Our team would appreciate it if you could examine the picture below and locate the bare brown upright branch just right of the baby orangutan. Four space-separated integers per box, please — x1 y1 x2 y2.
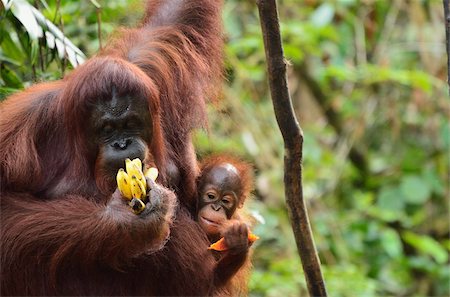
257 0 327 296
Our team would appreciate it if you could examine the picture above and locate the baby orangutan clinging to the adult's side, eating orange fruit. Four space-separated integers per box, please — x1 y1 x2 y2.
197 155 253 296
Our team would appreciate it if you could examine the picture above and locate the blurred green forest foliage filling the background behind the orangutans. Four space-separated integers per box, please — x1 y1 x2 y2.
0 0 450 296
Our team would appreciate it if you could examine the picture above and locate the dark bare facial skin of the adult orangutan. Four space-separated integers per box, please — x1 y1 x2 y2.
91 94 152 176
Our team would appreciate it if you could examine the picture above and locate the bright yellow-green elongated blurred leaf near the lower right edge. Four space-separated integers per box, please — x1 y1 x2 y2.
402 231 448 264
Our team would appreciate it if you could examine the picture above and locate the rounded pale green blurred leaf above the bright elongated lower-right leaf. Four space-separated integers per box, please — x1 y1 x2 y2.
400 175 431 204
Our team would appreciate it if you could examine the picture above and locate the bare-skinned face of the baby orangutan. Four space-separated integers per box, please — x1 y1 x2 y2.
197 163 241 237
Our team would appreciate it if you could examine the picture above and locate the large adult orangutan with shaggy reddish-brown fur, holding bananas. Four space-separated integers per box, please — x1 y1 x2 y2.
0 0 248 296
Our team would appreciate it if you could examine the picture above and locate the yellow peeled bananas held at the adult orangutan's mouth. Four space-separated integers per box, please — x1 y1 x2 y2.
116 158 158 214
